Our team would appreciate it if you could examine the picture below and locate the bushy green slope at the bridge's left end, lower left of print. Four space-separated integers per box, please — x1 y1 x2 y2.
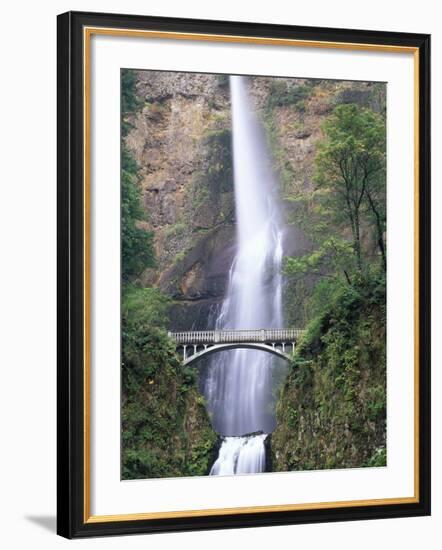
122 286 217 479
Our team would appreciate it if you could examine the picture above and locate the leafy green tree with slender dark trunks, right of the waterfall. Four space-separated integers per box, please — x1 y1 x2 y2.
314 104 386 273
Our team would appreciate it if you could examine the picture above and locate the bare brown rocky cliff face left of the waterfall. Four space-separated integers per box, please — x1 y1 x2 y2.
126 71 234 330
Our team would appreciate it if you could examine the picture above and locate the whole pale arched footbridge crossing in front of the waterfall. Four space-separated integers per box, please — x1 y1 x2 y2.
169 329 304 365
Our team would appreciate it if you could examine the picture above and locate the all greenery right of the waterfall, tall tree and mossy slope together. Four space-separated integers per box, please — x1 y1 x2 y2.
271 97 387 471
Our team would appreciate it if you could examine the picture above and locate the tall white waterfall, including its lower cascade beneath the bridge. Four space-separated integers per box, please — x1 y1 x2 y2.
205 76 283 475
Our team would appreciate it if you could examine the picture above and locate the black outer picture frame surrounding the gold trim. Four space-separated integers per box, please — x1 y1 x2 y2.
57 12 430 538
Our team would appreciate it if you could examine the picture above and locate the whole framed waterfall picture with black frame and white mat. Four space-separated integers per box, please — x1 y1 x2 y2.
58 12 430 538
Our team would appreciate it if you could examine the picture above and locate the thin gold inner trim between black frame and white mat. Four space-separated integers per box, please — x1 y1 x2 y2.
83 27 419 523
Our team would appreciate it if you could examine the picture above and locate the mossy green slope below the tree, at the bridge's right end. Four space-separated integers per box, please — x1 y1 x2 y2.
272 276 386 471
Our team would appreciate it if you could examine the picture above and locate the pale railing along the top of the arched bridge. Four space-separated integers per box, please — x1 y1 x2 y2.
169 328 304 344
